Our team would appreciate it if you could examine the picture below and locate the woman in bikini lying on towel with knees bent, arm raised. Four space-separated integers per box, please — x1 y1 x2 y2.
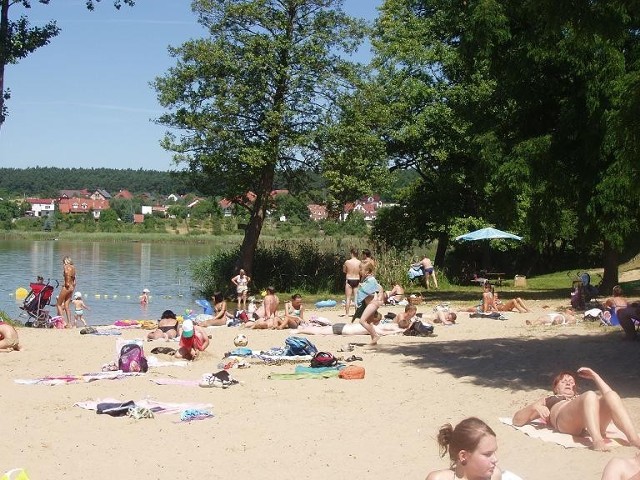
513 367 640 451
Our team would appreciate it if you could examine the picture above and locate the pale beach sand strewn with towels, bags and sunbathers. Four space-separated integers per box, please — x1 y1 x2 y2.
0 293 640 480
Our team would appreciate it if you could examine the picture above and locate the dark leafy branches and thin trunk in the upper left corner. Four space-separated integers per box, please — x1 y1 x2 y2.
0 0 135 128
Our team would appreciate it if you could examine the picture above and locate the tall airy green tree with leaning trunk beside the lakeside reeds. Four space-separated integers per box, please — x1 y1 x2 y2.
155 0 365 271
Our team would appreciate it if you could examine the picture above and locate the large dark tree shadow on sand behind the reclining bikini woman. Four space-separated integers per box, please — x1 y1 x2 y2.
377 327 640 397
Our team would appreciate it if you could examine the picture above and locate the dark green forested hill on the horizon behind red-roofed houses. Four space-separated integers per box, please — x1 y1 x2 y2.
0 167 188 197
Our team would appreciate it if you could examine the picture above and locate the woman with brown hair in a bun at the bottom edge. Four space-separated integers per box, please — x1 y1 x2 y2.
427 417 503 480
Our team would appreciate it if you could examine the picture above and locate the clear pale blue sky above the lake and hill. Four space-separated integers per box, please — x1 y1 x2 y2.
0 0 382 170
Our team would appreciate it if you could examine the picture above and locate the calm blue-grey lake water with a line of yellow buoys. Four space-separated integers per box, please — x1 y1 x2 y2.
0 240 218 325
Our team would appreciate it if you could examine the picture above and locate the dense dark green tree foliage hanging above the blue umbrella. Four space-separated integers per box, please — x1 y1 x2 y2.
370 0 640 286
